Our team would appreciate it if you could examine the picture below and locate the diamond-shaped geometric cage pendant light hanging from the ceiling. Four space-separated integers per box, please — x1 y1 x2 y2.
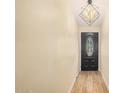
79 0 100 25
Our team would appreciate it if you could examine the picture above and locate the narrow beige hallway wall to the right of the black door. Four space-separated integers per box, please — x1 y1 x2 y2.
101 0 109 88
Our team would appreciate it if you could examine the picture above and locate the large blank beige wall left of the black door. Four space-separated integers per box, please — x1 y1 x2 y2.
16 0 78 93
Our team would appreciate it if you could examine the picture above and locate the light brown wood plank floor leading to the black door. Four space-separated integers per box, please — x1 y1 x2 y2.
71 71 108 93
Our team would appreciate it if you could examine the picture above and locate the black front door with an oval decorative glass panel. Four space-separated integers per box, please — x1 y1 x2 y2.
81 32 98 71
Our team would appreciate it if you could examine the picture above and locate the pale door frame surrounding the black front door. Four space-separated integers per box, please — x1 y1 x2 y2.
79 31 101 71
